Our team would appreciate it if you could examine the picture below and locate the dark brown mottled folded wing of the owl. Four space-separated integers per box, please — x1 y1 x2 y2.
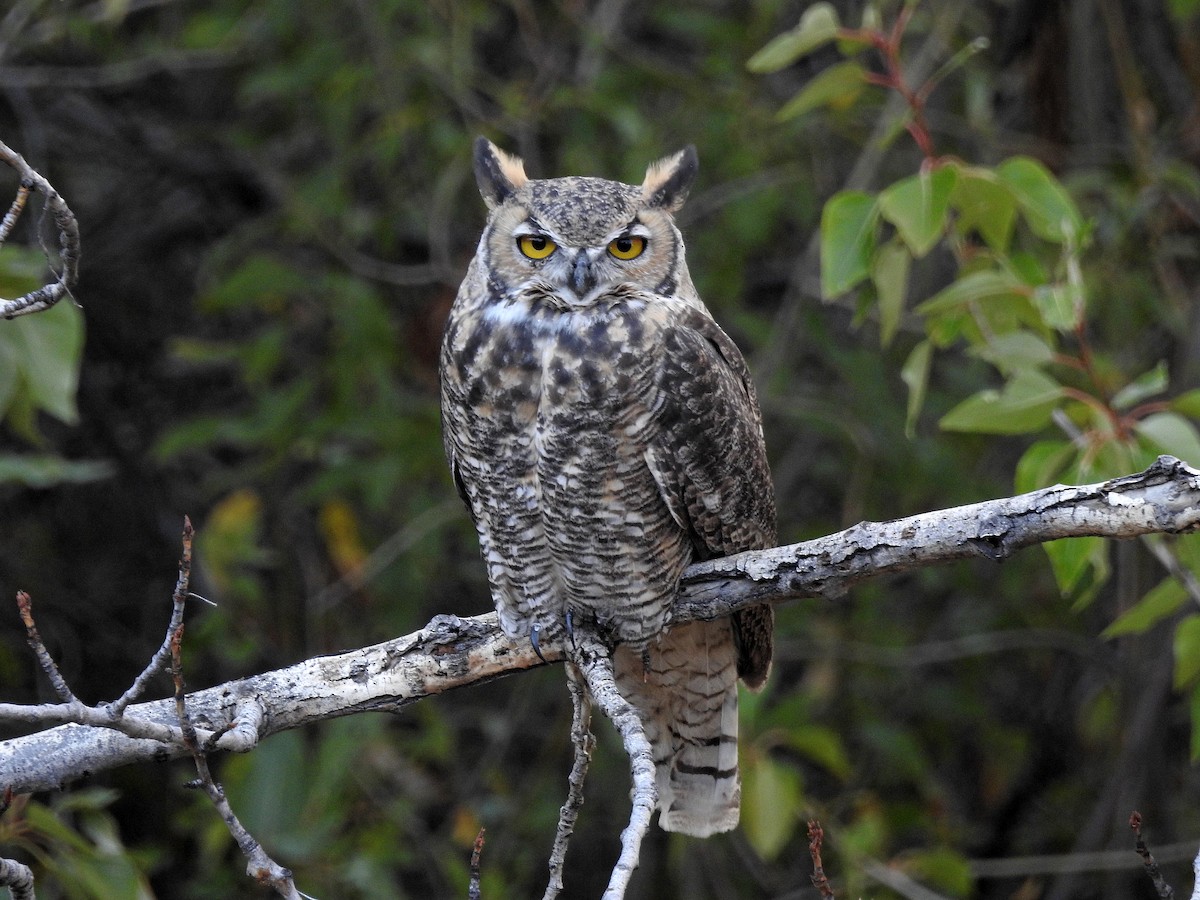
646 308 775 688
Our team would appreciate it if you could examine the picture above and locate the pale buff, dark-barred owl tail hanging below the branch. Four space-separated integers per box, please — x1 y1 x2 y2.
614 619 742 838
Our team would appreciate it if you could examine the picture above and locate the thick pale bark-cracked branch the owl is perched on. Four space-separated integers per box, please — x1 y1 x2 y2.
0 456 1200 793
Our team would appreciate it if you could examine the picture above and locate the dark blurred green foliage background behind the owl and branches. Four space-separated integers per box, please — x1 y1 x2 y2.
0 0 1200 900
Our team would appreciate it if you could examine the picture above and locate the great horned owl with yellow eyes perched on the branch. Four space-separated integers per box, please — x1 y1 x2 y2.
442 138 775 836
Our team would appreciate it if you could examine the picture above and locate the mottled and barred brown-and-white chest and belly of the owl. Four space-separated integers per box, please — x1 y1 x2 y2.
444 290 691 644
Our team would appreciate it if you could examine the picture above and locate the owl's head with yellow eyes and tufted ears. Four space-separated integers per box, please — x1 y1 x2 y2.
475 138 698 310
